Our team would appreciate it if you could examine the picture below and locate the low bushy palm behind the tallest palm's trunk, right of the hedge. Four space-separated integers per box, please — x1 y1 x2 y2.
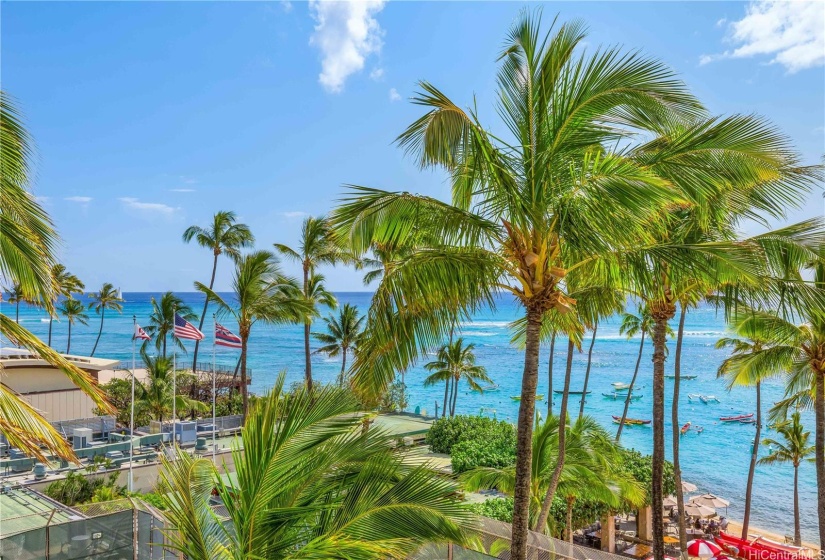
461 415 647 541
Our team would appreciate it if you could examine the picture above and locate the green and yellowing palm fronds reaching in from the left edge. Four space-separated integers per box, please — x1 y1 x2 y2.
0 90 113 462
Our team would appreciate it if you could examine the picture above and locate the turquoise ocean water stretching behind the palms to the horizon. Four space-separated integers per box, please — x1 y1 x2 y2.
1 292 817 540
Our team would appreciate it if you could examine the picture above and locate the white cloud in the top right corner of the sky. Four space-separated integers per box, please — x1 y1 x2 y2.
699 0 825 74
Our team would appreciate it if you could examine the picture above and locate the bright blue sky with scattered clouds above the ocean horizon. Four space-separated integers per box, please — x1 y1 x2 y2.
0 0 825 292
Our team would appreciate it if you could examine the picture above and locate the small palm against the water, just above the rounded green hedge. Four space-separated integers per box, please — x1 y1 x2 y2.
424 337 492 416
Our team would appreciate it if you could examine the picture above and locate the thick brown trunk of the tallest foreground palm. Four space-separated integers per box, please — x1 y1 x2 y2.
510 305 544 560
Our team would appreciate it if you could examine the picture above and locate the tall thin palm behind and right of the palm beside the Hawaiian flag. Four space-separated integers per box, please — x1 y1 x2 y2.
274 216 345 388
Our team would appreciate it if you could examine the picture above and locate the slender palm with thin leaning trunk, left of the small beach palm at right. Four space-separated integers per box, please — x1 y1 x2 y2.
716 305 777 539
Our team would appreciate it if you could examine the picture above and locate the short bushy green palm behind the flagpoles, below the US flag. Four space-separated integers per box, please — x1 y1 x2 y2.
135 348 209 422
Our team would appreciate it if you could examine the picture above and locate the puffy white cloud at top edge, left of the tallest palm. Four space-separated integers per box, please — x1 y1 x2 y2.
309 0 385 93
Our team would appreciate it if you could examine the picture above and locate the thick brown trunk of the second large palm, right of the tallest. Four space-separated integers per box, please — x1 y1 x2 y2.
651 301 676 560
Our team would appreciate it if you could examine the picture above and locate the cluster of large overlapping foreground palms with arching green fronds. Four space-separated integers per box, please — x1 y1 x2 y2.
331 12 825 560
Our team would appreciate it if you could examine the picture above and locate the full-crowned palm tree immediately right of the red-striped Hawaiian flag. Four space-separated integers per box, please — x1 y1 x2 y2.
195 251 316 419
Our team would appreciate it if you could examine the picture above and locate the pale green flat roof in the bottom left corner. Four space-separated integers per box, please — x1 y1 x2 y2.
0 487 83 538
